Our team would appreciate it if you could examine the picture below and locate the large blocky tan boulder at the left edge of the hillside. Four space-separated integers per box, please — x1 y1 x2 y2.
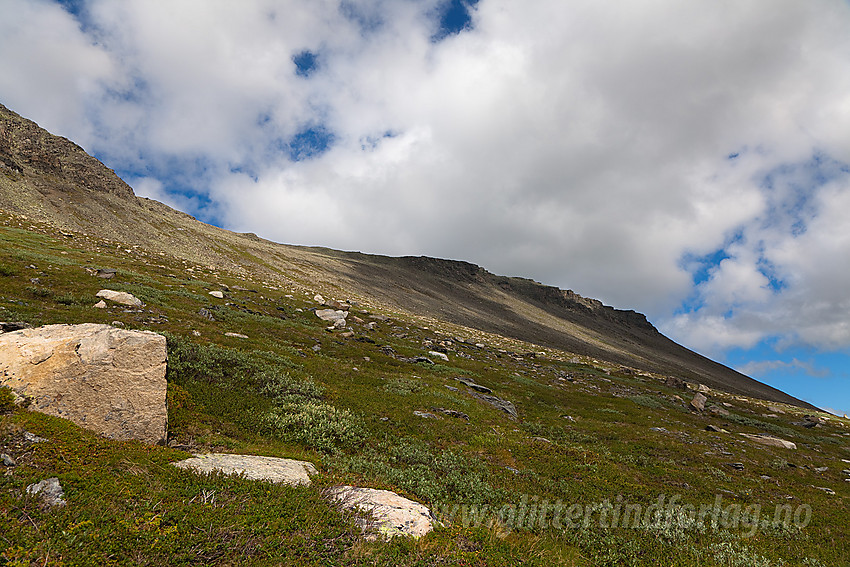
0 323 168 443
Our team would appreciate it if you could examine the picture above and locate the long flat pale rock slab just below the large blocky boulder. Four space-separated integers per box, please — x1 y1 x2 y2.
173 453 319 486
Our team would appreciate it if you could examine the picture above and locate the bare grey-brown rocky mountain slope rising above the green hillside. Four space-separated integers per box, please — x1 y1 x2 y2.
0 105 812 407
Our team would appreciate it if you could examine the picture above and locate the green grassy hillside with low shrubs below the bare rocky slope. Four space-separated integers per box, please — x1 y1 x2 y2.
0 211 850 566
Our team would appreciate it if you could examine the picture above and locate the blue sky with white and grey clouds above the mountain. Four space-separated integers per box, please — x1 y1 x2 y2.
0 0 850 413
